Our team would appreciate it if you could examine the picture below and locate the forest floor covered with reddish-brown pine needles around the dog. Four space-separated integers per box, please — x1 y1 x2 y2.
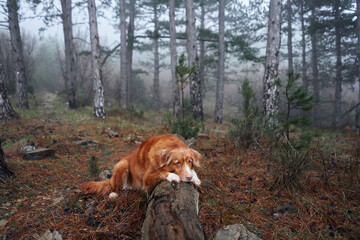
0 94 360 239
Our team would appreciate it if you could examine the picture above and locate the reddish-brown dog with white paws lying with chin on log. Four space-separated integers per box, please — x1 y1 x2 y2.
80 135 201 197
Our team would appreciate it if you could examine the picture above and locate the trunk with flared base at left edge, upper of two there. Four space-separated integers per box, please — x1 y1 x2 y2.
0 62 19 122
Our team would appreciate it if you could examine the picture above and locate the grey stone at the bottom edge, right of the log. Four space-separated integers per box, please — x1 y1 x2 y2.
215 224 261 240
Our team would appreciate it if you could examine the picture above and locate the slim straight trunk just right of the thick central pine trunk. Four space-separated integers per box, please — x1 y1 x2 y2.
215 0 225 123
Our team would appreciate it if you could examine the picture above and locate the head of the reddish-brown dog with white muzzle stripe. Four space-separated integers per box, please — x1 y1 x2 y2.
159 148 201 182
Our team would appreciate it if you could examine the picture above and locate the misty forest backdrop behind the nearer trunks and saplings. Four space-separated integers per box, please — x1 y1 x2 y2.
1 0 360 127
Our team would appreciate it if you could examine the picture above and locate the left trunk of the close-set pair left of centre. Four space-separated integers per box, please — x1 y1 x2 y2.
119 0 129 109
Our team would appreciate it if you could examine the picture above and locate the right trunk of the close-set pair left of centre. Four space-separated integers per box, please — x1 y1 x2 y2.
127 0 136 104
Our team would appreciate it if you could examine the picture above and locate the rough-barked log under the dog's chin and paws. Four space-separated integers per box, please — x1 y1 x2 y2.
141 181 205 240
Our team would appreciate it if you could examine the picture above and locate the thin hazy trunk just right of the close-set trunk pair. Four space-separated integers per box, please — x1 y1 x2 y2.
153 3 160 110
